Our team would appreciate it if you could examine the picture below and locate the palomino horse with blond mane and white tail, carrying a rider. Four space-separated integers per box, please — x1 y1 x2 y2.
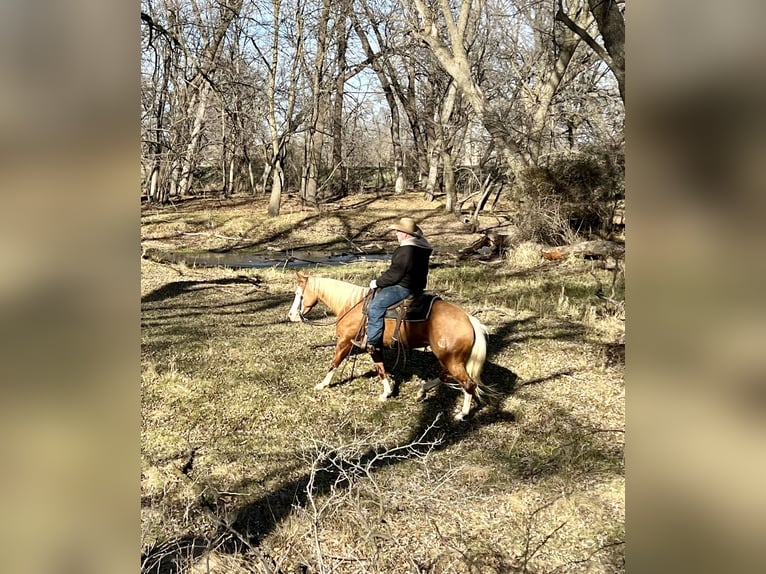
287 272 488 420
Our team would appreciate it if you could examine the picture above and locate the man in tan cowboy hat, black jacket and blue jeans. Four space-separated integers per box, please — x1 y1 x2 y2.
367 217 433 353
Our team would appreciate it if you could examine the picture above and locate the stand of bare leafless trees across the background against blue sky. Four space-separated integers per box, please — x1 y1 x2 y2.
141 0 624 215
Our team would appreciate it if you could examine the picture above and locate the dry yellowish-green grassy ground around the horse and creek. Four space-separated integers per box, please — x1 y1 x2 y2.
141 195 625 573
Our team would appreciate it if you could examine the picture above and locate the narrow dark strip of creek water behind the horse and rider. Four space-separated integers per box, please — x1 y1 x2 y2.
143 249 391 269
